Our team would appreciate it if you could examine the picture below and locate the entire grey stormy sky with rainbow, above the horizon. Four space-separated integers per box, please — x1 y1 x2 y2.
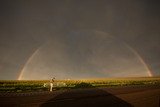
0 0 160 79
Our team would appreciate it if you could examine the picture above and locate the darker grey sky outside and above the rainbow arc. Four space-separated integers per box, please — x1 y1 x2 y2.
0 0 160 79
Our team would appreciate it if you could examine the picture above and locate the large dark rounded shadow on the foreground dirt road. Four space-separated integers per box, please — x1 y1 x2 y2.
40 88 133 107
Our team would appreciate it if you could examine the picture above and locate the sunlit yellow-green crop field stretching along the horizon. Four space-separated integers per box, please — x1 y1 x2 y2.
0 77 160 93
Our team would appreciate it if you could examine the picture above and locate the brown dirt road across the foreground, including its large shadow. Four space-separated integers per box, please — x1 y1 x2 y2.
0 87 160 107
